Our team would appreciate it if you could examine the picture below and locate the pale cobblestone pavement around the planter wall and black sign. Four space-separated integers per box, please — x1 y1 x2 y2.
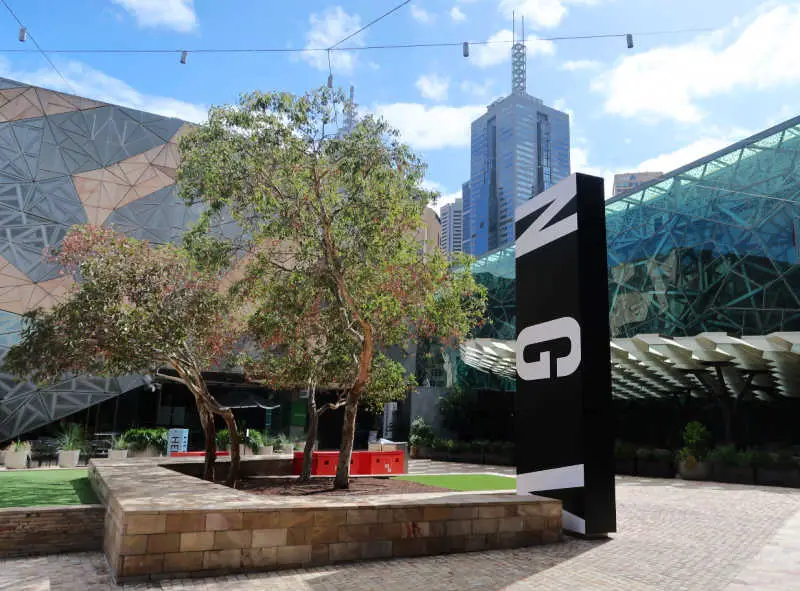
0 474 800 591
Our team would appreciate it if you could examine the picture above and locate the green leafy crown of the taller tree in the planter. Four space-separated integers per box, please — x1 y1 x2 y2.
178 88 486 476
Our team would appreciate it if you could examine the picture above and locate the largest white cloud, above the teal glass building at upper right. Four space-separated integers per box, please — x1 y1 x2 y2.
592 3 800 123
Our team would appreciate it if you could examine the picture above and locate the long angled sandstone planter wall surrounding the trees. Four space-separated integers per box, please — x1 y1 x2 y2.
89 458 562 581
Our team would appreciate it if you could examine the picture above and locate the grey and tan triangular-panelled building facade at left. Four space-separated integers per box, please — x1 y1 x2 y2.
0 78 200 441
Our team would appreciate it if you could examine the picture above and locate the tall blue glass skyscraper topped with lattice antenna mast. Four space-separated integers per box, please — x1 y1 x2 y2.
463 31 570 256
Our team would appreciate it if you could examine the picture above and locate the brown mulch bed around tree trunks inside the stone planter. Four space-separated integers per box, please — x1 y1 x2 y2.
237 477 447 497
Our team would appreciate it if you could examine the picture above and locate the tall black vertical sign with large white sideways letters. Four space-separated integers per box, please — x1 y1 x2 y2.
515 174 616 536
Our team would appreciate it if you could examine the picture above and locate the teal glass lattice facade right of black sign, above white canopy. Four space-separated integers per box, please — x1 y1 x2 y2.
606 118 800 337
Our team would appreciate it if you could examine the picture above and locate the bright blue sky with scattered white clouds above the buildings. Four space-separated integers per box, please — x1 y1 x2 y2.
0 0 800 210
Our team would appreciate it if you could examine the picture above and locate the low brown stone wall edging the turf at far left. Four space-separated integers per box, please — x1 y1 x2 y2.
0 505 105 558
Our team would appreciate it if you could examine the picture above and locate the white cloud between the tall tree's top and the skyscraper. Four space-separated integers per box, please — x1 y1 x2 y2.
373 103 486 150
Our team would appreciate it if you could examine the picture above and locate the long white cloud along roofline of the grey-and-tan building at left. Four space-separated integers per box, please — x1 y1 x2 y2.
0 59 208 123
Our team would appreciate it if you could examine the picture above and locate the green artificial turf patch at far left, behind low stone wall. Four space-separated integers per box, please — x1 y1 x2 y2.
0 468 98 507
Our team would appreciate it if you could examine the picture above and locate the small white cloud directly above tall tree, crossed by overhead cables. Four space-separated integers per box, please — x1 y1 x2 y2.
301 6 364 74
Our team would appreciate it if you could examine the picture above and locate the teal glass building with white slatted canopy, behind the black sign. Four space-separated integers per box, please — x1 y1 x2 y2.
460 117 800 398
